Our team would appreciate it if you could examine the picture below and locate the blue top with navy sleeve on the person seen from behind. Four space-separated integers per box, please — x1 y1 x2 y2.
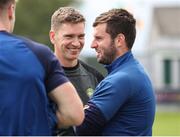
0 31 68 136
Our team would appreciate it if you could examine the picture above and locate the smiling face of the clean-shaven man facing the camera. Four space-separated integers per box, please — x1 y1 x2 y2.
50 22 85 67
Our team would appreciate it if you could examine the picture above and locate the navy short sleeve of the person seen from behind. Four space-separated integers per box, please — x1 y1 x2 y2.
24 39 69 92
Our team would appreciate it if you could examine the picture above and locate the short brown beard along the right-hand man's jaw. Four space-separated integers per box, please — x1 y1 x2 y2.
98 41 117 65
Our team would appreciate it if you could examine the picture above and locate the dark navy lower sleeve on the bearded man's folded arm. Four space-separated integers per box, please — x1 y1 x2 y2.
75 101 106 136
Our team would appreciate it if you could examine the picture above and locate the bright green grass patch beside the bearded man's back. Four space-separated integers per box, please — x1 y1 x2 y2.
153 112 180 136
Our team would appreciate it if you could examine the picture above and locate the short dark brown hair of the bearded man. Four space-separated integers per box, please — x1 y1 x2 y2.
93 9 136 49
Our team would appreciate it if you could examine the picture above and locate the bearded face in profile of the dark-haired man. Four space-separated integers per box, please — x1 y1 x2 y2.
91 23 117 65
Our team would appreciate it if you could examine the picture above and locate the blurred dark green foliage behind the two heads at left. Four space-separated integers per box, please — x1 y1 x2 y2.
14 0 73 48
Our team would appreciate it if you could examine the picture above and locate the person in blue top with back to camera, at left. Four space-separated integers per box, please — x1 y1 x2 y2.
0 0 84 136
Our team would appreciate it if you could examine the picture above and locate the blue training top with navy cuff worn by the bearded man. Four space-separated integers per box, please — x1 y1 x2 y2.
76 51 155 136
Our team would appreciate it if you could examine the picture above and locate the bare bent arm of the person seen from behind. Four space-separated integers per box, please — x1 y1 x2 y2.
49 82 84 128
